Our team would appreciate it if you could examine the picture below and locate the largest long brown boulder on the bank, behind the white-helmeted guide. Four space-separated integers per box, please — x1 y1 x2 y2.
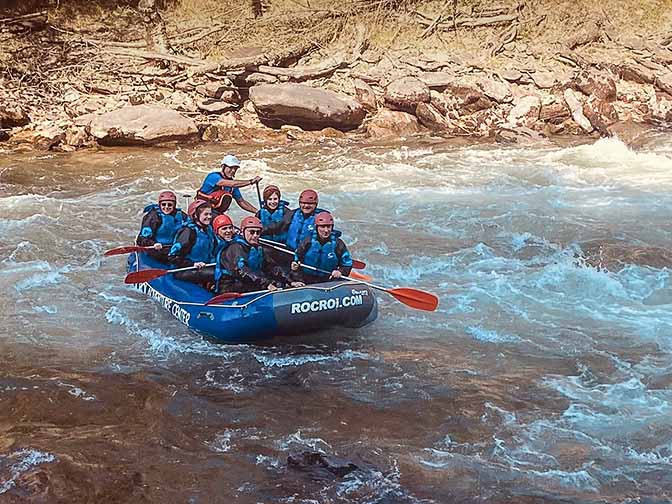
250 84 366 131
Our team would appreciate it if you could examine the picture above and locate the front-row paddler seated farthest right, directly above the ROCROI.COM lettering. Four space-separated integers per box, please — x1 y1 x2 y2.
292 212 352 284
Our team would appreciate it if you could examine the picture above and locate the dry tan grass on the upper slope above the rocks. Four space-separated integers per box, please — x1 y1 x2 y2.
35 0 672 65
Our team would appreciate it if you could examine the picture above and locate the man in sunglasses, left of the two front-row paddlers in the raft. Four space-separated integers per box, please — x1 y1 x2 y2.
215 217 304 293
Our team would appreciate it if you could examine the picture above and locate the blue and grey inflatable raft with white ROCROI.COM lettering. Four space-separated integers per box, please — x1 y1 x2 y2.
128 253 378 343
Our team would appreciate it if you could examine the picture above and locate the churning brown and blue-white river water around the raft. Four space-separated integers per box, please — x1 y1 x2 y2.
0 135 672 503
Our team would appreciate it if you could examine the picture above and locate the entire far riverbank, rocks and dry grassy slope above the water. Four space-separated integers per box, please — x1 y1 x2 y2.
0 0 672 151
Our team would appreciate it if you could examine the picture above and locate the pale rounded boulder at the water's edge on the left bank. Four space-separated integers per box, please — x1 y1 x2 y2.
89 105 198 145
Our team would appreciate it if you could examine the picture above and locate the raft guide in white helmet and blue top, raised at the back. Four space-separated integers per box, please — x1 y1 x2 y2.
196 154 261 214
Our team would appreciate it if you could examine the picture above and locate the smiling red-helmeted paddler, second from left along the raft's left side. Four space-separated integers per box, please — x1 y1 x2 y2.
168 200 217 287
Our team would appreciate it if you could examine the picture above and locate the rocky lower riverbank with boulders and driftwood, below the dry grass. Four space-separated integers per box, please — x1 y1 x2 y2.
0 3 672 151
